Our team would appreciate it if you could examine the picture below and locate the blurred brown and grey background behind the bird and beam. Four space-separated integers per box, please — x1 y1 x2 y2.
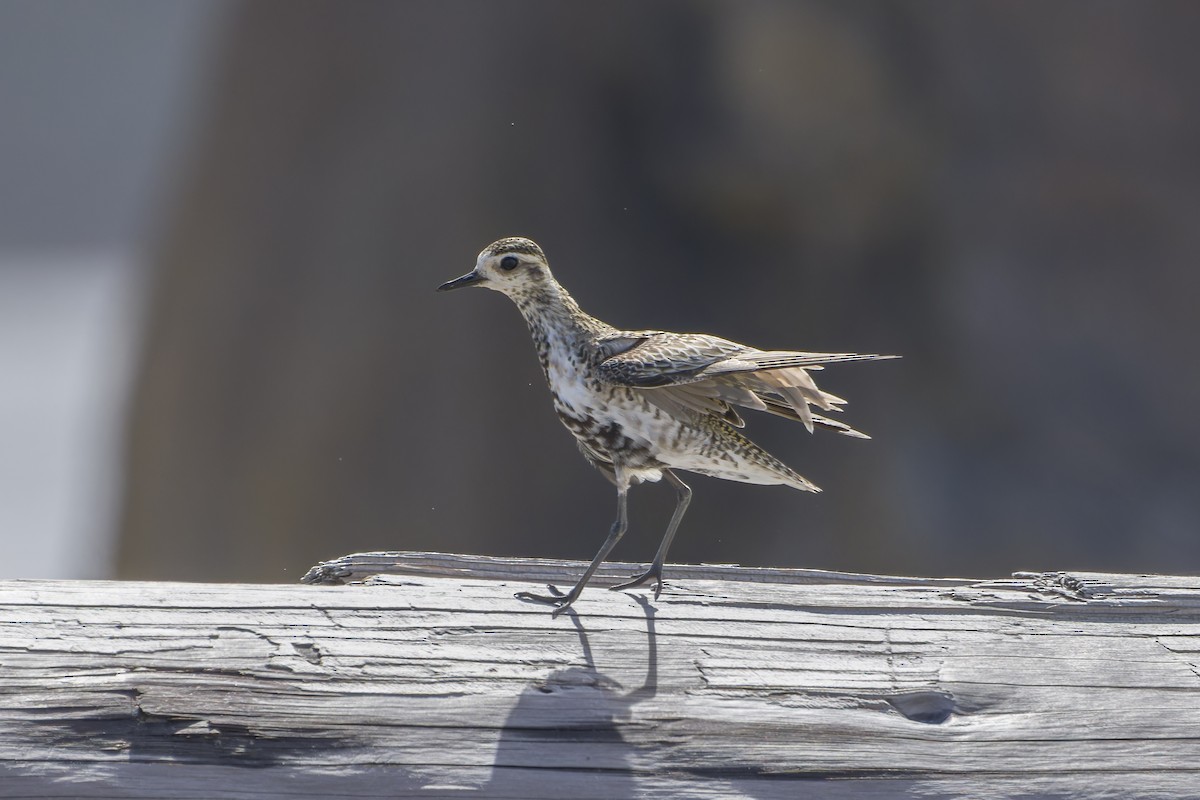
0 0 1200 581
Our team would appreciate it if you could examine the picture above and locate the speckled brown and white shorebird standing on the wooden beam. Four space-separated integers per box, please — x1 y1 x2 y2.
438 236 898 616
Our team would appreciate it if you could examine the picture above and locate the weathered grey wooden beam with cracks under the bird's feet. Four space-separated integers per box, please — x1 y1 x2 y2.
0 553 1200 800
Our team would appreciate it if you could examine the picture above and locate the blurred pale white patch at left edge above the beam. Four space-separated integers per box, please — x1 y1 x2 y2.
0 252 140 578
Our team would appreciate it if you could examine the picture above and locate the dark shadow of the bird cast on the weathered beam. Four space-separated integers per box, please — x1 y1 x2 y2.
481 597 659 798
